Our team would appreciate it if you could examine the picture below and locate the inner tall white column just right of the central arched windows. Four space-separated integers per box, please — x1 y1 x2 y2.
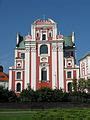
52 43 57 89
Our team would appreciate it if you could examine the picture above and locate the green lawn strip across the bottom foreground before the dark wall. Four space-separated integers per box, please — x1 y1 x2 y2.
0 108 90 120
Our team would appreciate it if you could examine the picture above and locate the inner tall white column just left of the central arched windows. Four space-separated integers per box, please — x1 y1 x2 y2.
31 46 36 90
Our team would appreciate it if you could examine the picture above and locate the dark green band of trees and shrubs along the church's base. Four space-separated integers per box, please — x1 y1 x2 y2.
0 85 90 102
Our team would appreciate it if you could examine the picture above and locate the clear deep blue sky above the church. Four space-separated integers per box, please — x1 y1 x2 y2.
0 0 90 73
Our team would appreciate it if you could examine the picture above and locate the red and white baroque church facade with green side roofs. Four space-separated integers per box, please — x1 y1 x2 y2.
9 18 79 93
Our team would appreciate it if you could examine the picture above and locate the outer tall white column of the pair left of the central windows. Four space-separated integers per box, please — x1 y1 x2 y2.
24 48 30 89
